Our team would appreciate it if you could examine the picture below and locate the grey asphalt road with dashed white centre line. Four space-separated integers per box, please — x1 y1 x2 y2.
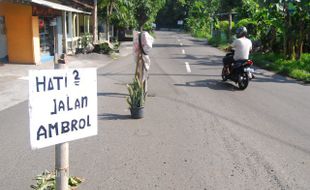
0 32 310 190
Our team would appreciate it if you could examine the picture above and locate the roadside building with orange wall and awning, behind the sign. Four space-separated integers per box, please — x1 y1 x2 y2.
0 0 93 64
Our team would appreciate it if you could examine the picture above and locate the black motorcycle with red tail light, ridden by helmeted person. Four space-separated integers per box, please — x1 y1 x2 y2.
222 51 254 90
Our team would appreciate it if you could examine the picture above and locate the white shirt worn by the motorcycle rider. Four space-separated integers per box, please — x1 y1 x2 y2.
231 37 252 60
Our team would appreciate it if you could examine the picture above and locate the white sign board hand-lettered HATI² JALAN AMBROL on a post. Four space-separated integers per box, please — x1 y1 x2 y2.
29 68 97 149
